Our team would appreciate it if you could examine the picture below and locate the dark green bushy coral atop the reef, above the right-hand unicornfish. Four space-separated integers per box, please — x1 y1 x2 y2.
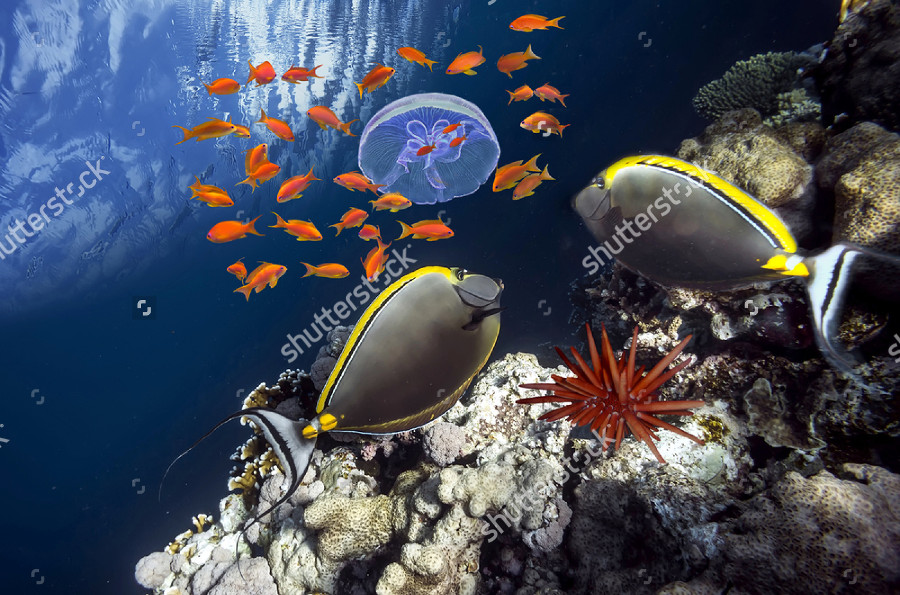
693 52 813 120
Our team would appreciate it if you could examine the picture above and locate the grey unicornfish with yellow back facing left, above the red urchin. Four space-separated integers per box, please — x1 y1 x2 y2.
574 155 888 374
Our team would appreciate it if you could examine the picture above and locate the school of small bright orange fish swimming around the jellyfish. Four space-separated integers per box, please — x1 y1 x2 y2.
174 14 568 301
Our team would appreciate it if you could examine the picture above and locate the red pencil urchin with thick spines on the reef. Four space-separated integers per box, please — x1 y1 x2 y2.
516 324 704 463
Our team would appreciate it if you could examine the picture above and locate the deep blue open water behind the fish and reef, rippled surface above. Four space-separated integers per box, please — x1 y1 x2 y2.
0 0 839 594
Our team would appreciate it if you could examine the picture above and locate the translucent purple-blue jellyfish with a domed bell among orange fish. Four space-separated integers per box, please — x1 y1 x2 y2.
359 93 500 205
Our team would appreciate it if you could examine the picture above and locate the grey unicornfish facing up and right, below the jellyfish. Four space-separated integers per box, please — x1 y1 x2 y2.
169 266 503 530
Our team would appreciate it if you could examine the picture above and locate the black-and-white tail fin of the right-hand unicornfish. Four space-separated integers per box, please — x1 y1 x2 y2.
806 243 864 377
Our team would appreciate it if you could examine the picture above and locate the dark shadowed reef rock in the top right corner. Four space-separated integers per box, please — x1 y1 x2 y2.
813 0 900 132
